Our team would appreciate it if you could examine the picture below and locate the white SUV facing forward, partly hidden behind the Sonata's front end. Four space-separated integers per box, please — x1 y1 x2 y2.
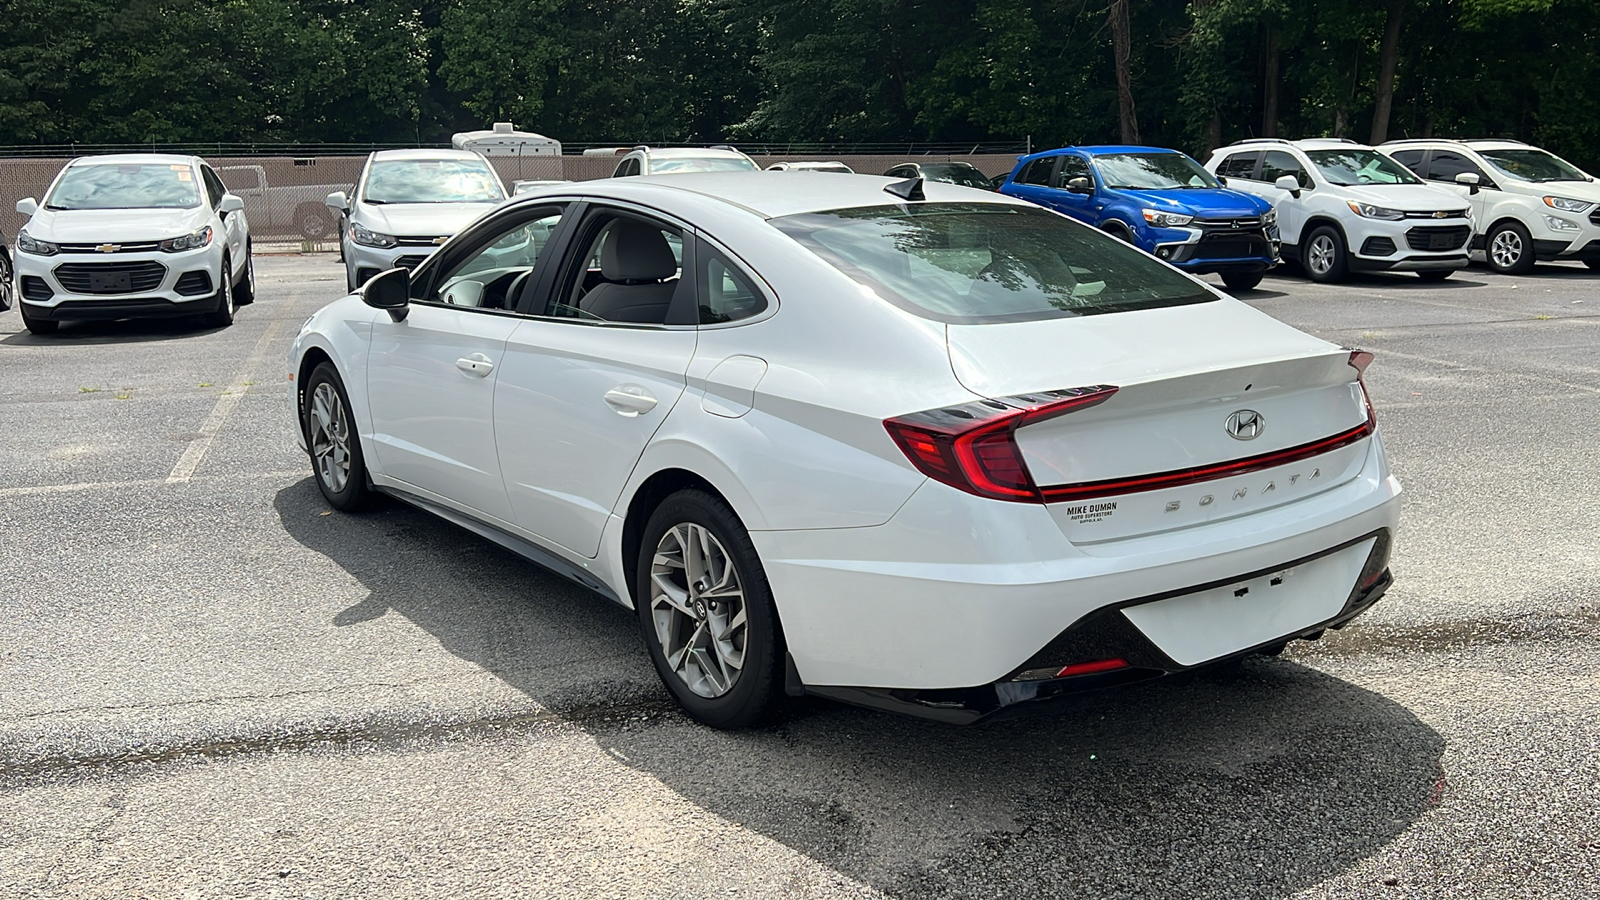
326 151 506 290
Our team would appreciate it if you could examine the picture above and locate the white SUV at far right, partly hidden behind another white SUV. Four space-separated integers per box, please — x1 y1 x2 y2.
1378 139 1600 275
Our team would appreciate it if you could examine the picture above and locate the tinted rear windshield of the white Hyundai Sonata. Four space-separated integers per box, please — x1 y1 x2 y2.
771 203 1216 323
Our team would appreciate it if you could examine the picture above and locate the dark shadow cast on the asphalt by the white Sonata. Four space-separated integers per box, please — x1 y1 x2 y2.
275 479 1443 900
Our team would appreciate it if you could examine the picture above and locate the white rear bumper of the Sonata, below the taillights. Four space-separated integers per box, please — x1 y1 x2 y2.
750 437 1400 695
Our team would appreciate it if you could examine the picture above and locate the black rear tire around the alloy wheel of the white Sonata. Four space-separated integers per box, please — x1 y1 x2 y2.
634 490 784 729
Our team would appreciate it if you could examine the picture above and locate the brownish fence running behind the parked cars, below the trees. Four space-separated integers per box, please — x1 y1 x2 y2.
0 152 1016 251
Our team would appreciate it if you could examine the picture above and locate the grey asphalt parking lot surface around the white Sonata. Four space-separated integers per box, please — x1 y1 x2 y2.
0 255 1600 900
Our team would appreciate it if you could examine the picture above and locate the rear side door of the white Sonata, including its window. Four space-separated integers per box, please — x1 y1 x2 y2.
494 205 698 557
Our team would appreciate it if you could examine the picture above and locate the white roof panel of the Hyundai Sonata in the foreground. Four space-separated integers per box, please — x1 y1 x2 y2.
517 170 1034 219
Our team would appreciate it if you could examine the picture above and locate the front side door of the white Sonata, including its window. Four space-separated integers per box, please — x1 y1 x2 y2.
366 196 565 522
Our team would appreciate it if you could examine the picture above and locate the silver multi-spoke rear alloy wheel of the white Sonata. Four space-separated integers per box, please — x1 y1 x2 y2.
650 522 747 698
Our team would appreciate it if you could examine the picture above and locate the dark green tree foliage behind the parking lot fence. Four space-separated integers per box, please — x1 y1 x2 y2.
0 0 1600 167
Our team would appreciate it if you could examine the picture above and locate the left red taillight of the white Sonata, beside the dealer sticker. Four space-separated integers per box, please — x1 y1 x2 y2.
883 384 1117 503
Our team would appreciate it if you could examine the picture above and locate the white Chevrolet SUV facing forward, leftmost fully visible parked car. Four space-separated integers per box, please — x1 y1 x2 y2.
13 154 256 335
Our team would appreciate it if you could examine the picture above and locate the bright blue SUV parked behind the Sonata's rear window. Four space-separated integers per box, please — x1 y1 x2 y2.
1000 147 1278 290
